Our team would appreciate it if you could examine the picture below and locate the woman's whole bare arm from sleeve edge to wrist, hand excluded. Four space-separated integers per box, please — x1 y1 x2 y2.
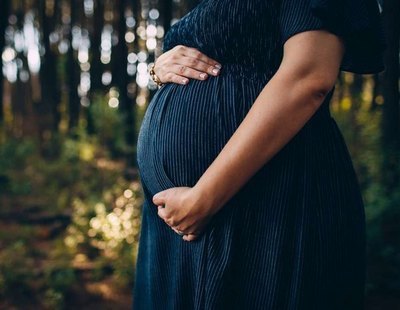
193 30 344 217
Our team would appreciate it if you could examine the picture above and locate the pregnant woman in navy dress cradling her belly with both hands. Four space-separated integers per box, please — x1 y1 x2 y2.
133 0 385 310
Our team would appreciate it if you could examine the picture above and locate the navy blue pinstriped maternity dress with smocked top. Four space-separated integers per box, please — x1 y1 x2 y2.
133 0 385 310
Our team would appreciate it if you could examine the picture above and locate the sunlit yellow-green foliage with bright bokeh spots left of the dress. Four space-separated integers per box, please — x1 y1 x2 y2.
64 180 142 286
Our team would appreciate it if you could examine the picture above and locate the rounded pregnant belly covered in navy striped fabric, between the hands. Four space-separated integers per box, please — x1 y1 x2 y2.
137 73 266 193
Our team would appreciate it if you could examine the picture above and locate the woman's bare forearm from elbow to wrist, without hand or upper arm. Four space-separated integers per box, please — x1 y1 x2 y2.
194 75 332 213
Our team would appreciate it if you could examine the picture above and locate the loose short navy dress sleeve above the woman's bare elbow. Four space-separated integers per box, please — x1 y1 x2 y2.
279 0 386 74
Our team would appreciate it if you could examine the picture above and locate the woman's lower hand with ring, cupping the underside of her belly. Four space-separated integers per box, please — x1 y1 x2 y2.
153 187 213 241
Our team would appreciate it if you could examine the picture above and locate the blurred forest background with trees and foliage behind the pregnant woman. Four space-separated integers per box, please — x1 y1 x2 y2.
0 0 400 309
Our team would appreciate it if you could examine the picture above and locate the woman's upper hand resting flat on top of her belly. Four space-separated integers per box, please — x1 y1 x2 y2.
154 45 221 84
